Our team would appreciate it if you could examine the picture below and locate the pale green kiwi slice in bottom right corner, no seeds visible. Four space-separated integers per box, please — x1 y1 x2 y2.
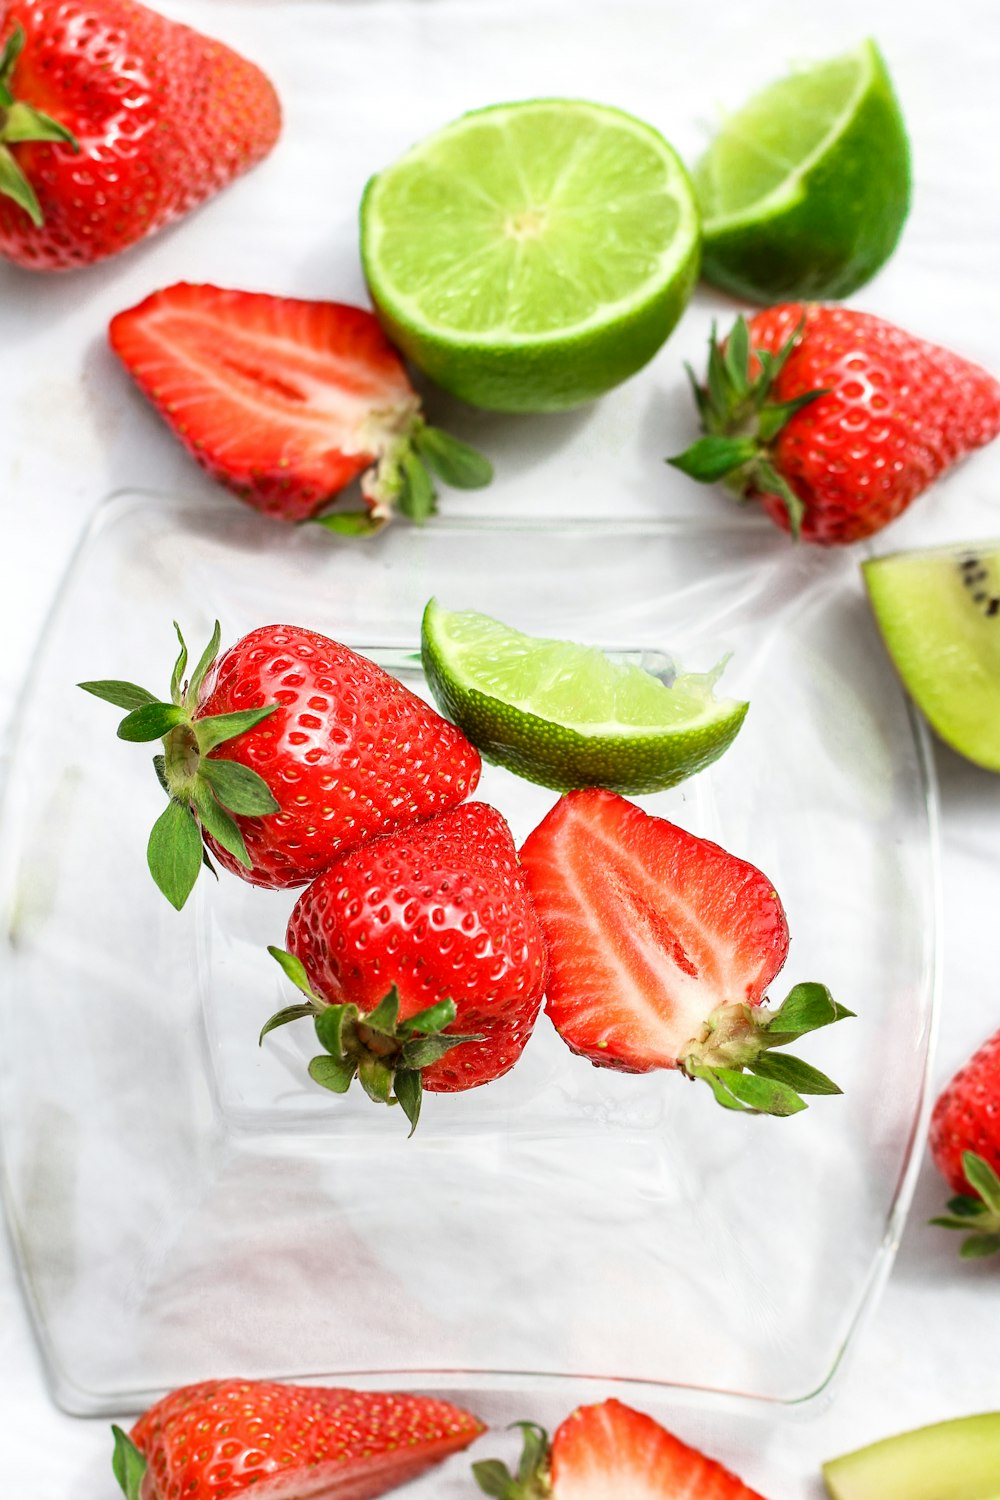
823 1412 1000 1500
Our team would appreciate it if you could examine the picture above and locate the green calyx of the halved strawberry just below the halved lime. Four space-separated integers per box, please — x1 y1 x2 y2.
313 405 493 537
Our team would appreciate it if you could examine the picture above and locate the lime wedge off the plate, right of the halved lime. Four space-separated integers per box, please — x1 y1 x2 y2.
694 41 910 303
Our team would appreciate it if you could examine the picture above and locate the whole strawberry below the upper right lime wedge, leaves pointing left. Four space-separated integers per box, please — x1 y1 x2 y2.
670 303 1000 545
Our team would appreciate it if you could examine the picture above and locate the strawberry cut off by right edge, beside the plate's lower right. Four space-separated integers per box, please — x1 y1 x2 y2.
930 1032 1000 1257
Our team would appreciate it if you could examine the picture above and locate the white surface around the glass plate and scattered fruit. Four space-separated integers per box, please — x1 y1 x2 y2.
0 0 1000 1500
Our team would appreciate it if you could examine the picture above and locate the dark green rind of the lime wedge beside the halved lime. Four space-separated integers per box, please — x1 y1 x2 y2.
693 41 910 303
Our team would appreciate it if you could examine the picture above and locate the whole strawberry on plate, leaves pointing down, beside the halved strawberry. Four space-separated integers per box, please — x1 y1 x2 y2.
264 803 546 1127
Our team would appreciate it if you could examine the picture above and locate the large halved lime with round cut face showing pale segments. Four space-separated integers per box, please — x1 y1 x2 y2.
361 99 700 411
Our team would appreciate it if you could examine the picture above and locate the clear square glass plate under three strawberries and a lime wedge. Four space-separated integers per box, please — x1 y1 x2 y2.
0 494 937 1413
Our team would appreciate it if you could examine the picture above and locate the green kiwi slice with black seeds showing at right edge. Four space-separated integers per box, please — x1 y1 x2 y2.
861 542 1000 774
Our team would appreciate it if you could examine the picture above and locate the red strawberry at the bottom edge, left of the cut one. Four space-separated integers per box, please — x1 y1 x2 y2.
114 1380 484 1500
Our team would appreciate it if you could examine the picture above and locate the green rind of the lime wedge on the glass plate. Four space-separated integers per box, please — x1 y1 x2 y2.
421 600 748 797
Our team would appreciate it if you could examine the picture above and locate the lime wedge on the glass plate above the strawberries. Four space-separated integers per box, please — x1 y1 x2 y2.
421 599 748 797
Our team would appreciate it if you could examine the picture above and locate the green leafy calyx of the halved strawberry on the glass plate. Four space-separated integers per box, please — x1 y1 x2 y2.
678 983 855 1116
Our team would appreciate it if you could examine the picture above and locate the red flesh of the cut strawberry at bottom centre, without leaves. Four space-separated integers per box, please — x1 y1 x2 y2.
550 1398 763 1500
